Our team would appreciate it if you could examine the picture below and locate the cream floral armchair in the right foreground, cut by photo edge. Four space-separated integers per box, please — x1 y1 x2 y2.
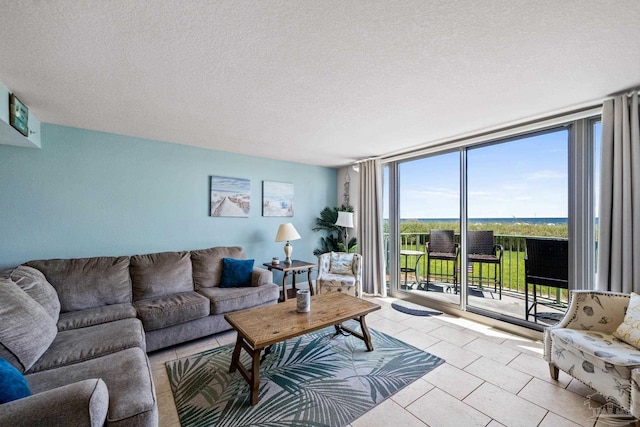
544 290 640 425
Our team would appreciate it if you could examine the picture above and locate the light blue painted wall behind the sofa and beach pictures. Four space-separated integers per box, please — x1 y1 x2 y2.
0 123 337 270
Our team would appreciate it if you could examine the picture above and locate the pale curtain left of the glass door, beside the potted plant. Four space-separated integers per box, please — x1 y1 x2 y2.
357 159 387 297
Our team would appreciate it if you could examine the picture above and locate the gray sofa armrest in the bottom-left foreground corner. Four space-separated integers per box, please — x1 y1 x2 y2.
0 379 109 427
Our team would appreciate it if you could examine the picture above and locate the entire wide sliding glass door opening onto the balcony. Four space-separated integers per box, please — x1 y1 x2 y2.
385 116 600 330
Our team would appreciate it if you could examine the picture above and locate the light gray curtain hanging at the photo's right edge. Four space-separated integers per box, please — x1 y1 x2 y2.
597 92 640 293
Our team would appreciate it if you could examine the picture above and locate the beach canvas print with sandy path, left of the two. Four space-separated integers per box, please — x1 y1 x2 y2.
209 176 251 218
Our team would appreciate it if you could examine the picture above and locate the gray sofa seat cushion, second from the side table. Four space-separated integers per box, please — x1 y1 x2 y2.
134 292 209 331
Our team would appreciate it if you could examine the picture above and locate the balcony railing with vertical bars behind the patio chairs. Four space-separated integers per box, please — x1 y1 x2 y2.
384 232 568 304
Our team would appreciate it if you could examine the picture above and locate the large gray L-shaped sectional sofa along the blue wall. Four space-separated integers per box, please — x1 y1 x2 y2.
0 247 279 427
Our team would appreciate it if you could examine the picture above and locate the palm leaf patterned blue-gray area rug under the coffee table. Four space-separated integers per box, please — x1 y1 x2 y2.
166 322 444 427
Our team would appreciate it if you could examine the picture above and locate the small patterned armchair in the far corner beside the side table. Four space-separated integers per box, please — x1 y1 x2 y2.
316 252 362 297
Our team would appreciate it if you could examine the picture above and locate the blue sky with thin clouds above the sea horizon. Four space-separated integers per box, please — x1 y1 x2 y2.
384 129 568 219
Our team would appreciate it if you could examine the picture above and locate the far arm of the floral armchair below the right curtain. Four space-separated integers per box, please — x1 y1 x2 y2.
544 290 630 362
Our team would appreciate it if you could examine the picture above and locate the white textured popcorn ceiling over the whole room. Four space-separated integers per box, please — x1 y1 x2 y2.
0 0 640 166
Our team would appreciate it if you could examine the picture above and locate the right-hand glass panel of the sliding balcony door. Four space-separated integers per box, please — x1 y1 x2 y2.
465 127 569 323
